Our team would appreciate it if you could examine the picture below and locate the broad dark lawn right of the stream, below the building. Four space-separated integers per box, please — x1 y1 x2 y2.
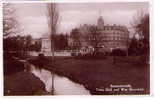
46 57 150 95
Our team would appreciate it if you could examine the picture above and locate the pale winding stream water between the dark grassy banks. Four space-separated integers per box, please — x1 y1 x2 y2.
31 65 90 95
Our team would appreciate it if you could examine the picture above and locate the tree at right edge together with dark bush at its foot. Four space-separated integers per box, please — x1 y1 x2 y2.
129 11 150 54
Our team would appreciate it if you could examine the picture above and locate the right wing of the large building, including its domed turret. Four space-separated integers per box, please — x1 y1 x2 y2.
97 17 129 51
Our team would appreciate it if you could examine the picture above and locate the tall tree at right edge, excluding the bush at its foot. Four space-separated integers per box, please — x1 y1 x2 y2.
132 11 150 53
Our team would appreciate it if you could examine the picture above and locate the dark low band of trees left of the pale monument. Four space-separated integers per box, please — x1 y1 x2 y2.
3 35 41 57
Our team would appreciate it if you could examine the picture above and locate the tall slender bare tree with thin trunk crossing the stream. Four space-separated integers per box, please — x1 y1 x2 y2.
47 3 59 95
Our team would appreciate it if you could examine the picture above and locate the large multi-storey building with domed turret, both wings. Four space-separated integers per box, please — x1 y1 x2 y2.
69 16 129 51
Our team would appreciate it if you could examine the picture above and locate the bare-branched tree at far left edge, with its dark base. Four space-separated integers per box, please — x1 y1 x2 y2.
3 3 26 56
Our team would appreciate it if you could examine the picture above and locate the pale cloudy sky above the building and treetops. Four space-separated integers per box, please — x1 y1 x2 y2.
8 2 148 38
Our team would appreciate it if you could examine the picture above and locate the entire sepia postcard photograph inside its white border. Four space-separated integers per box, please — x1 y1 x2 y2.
2 2 150 96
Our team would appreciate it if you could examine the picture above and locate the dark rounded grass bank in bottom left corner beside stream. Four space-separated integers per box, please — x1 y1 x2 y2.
4 71 45 96
